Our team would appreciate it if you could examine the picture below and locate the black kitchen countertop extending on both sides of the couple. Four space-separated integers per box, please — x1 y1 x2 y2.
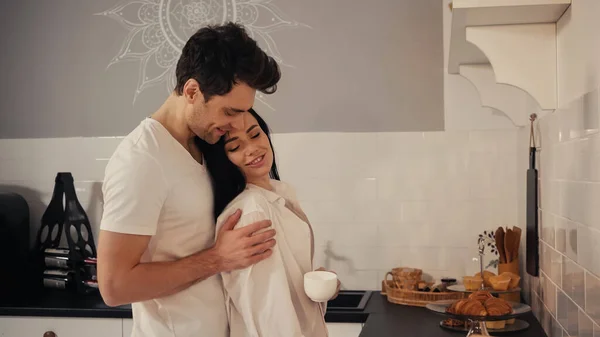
0 290 546 337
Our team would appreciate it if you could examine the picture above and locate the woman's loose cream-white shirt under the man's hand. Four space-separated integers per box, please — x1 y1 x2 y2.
216 180 327 337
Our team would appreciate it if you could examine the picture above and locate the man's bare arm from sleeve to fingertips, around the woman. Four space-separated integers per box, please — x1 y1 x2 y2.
98 211 275 306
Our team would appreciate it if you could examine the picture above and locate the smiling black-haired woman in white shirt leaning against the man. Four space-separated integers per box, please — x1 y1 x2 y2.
201 109 339 337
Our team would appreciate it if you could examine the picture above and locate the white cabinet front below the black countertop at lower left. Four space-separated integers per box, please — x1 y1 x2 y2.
0 316 123 337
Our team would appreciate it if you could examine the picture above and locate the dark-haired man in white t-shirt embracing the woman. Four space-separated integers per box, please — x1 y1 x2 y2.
98 23 281 337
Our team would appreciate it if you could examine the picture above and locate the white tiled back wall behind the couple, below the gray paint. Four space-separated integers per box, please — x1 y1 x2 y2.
0 130 517 289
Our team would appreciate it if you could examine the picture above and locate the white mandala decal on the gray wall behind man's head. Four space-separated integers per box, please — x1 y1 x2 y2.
96 0 310 109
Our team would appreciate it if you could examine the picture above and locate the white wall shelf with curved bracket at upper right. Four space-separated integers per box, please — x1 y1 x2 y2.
448 0 571 111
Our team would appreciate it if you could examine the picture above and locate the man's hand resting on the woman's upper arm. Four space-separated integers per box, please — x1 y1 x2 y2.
213 210 275 272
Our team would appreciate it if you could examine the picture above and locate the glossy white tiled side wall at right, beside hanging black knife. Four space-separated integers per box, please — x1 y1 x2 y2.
517 89 600 337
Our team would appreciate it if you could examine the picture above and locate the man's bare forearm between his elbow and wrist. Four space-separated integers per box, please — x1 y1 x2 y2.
99 245 220 306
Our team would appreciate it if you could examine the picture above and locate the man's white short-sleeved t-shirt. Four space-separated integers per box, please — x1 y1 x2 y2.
100 118 229 337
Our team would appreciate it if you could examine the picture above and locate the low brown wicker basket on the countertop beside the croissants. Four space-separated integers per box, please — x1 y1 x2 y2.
381 274 464 307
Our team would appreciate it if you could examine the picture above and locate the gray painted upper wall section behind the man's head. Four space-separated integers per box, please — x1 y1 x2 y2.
0 0 444 138
